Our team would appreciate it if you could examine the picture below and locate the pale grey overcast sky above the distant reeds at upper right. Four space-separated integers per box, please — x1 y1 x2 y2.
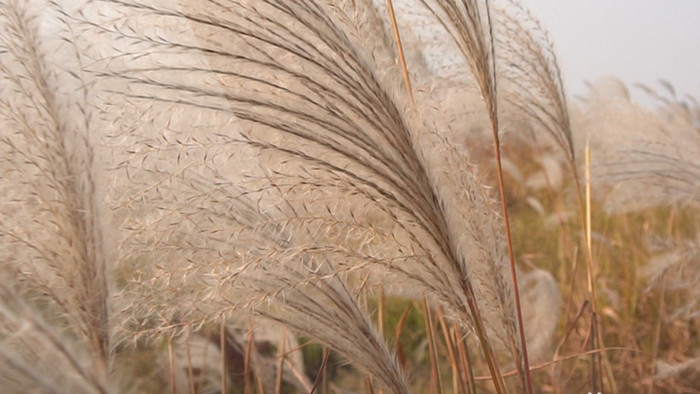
522 0 700 98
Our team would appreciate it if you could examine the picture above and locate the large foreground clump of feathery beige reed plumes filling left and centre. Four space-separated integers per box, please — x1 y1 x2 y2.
0 0 575 393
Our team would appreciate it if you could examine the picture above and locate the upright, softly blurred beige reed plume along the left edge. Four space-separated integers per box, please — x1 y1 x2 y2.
0 1 112 392
